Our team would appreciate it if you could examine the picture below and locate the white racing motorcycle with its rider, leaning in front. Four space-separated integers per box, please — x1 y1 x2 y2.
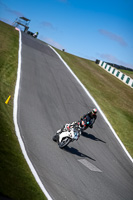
53 122 81 149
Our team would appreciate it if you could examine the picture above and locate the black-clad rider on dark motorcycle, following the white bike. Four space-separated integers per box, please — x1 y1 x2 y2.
81 108 97 128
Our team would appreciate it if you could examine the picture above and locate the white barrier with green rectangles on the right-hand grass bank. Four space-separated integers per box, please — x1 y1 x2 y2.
99 60 133 88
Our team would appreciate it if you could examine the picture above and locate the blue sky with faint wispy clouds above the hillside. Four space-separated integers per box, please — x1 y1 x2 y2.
0 0 133 69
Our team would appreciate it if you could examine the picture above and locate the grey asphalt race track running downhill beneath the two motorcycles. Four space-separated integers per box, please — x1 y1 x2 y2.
18 33 133 200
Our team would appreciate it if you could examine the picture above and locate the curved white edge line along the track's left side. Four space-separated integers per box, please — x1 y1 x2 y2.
13 31 52 200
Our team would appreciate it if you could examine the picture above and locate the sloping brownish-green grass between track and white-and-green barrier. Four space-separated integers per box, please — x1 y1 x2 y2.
52 48 133 157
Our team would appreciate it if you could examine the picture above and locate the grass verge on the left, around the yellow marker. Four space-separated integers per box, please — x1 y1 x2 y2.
0 21 46 200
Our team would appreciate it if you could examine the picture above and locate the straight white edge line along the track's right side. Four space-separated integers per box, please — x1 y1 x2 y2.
48 45 133 163
